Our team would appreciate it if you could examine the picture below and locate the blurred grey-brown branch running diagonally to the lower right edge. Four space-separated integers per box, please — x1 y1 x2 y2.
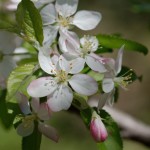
104 106 150 147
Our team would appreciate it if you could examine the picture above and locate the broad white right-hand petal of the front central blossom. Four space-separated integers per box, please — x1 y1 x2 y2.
69 74 98 96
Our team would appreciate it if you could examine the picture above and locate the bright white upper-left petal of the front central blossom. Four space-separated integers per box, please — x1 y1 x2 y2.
38 49 56 74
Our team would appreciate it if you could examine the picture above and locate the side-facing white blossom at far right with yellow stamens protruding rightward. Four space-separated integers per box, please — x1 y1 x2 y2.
102 46 131 93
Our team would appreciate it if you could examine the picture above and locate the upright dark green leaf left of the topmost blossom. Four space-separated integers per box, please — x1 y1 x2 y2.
16 0 43 45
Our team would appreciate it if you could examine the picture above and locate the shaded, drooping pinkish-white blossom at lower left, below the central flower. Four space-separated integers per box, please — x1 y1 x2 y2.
16 95 59 142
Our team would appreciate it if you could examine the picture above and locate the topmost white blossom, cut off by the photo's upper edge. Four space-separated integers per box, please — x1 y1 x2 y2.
40 0 101 44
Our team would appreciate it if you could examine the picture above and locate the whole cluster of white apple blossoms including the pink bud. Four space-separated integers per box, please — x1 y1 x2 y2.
14 0 129 142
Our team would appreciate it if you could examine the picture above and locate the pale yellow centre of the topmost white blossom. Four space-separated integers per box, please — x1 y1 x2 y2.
58 16 71 29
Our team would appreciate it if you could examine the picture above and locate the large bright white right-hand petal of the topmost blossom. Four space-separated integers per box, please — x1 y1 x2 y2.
73 10 101 30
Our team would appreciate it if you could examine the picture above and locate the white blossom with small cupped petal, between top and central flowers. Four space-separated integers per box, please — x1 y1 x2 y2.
59 33 107 73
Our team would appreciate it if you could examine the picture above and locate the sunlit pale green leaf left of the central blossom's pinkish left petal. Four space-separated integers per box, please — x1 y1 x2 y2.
7 64 38 102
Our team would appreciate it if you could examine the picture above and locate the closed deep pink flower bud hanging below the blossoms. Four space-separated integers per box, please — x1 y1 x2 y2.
90 111 108 142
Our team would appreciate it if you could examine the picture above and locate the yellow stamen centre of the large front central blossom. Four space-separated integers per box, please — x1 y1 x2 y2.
56 70 68 83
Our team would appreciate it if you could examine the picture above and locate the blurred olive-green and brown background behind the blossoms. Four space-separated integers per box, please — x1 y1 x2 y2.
0 0 150 150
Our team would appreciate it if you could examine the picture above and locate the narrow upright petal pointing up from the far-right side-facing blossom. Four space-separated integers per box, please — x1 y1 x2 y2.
115 45 124 75
